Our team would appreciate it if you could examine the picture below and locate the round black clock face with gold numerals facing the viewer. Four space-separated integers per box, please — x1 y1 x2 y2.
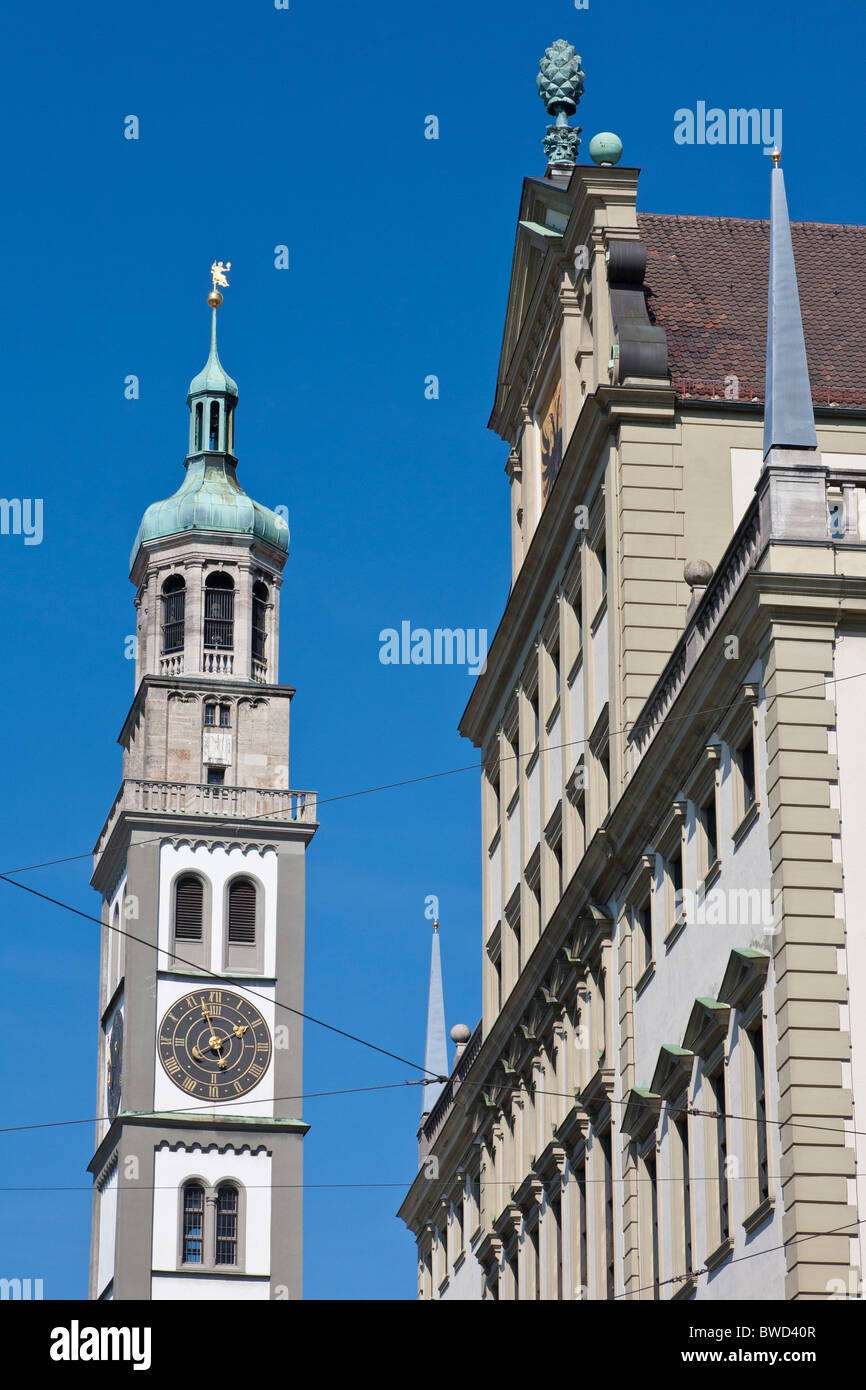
157 990 271 1101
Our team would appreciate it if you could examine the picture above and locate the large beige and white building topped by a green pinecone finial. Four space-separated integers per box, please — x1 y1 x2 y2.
400 43 866 1300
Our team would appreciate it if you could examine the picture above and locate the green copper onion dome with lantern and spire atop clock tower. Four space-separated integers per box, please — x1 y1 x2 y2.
129 296 289 569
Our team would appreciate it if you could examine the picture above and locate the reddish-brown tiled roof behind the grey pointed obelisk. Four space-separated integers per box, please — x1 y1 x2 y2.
638 213 866 406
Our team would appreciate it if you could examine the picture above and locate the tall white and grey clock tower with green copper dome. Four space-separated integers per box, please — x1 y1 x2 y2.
90 276 317 1300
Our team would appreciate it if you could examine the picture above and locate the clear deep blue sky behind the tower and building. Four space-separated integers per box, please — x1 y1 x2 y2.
0 0 866 1298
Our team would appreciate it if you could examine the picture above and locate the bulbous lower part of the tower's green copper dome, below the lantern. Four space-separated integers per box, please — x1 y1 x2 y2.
129 453 289 569
